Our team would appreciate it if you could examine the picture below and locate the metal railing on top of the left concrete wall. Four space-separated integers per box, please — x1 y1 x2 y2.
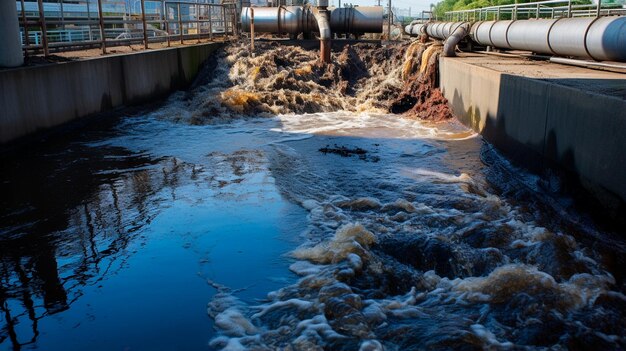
16 0 239 56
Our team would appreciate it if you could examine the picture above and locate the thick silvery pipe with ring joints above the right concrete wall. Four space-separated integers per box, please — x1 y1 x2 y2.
470 17 626 62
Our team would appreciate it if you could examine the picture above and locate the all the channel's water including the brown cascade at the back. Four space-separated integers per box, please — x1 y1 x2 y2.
0 43 626 351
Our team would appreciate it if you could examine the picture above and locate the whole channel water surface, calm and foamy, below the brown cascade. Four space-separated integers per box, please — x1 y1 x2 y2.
0 108 624 350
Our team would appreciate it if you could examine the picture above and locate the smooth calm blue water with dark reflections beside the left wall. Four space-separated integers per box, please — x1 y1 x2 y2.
0 115 306 350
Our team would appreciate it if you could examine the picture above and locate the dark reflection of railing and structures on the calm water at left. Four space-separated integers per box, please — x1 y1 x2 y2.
0 134 194 349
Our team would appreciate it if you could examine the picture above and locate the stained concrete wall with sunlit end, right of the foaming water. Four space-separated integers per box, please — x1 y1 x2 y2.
439 58 626 207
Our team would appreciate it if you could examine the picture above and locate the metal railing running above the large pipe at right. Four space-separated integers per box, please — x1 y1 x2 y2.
444 0 626 21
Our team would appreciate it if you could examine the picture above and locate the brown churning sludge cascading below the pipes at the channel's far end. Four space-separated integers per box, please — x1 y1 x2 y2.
164 42 451 124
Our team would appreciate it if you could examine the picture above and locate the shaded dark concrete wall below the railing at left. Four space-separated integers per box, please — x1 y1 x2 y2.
0 43 221 143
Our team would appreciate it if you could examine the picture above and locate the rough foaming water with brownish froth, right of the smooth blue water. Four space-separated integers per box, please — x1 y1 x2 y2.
202 112 626 350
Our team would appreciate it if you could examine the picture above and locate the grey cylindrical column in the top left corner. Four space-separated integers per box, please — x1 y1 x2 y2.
0 0 24 67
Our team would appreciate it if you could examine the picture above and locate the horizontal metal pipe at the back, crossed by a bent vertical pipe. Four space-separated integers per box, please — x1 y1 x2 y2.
241 6 383 34
